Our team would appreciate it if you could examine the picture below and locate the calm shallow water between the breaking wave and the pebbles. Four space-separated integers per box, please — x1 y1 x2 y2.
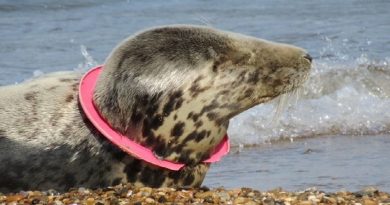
203 135 390 192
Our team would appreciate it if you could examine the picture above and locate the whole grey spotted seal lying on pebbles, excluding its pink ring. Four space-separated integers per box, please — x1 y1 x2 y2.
0 26 311 192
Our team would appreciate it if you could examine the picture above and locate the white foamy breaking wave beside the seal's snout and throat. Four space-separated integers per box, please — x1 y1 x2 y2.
228 55 390 146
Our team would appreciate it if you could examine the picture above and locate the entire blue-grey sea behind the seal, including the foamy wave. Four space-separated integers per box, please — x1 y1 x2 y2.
0 0 390 191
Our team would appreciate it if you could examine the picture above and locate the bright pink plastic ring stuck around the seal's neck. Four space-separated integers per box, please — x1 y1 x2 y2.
79 66 230 171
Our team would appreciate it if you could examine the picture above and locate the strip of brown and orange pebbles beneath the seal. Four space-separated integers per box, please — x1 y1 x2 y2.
0 184 390 205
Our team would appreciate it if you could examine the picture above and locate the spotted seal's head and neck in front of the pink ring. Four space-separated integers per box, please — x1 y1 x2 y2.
94 26 311 165
